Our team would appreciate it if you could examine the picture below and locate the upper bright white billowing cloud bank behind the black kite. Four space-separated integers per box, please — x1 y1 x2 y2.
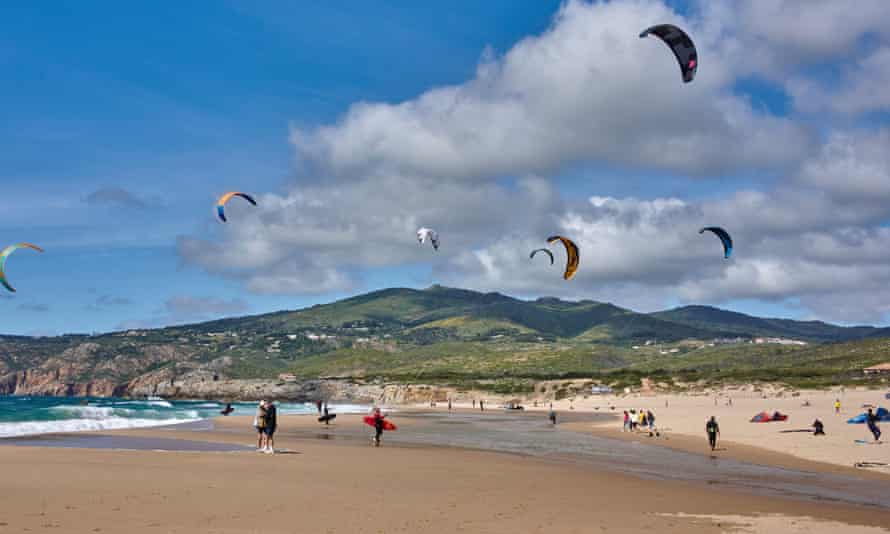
292 2 808 181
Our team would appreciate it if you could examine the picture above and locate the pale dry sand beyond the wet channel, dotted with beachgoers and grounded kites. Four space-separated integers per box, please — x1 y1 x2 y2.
510 390 890 476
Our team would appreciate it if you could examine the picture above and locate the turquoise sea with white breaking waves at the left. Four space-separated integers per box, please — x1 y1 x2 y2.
0 396 368 438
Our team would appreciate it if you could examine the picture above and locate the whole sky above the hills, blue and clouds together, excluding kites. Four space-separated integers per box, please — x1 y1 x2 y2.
0 0 890 335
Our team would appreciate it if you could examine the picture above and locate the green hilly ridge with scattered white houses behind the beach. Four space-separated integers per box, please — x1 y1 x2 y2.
0 286 890 391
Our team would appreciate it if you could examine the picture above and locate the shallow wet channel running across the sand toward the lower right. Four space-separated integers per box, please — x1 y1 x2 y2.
26 410 890 510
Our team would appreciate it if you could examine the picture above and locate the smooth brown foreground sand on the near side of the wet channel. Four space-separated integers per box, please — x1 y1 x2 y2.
0 411 890 533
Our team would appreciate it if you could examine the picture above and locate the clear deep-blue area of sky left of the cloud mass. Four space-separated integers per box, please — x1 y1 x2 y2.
0 1 558 333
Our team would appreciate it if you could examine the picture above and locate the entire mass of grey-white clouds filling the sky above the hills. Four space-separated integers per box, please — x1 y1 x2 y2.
177 0 890 321
